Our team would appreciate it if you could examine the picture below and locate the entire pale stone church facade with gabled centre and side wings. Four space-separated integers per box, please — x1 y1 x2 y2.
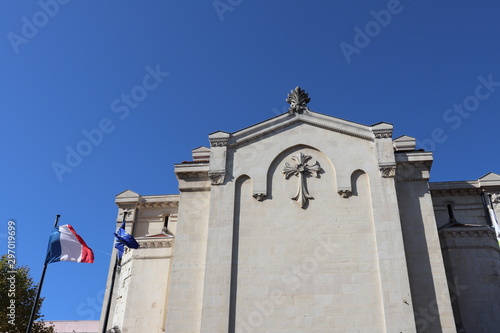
97 88 500 333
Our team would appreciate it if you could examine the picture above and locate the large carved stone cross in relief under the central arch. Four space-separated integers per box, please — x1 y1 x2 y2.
282 153 321 208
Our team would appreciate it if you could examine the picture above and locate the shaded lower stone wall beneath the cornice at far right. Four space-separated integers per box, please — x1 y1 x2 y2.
440 226 500 333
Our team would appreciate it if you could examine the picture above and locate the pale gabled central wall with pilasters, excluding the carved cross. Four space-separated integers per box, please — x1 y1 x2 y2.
197 118 415 332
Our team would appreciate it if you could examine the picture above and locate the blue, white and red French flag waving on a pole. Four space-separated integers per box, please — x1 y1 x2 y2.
45 224 94 264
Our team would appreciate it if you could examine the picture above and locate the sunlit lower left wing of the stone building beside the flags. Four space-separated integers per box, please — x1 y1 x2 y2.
99 190 179 333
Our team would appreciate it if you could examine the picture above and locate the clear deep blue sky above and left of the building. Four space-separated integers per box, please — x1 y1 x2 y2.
0 0 500 320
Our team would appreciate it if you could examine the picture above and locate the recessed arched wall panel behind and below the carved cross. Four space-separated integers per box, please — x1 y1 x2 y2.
230 147 384 332
